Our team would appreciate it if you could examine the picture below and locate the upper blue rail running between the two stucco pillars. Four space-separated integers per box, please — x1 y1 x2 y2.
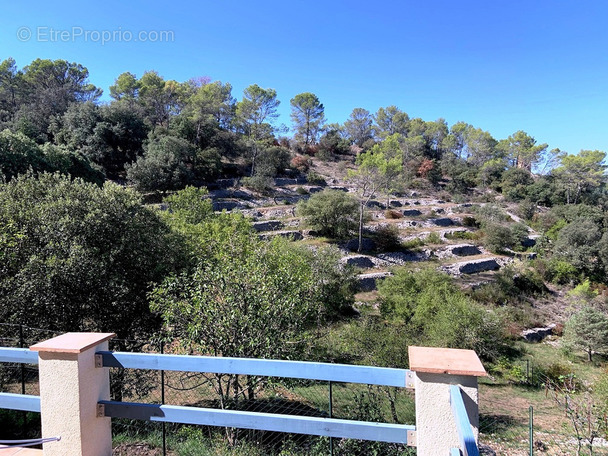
97 351 409 388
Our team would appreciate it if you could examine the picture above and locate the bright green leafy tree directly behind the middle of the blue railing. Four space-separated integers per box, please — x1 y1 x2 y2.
152 219 354 407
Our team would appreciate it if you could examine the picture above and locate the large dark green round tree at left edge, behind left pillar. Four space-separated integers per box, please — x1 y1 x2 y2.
0 174 180 339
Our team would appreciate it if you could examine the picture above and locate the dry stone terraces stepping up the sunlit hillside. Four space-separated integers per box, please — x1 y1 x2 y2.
201 178 536 291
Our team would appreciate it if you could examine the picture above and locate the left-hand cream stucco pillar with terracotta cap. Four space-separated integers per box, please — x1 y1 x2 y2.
30 333 115 456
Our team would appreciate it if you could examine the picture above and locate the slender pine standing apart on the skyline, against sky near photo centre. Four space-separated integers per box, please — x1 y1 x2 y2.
291 92 325 145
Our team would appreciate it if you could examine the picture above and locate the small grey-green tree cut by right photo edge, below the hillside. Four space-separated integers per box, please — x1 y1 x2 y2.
564 306 608 362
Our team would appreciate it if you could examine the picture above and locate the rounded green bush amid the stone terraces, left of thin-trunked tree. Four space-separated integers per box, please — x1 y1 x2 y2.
297 189 359 239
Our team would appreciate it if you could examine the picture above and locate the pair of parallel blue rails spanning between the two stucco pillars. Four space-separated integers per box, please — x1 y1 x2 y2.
97 351 415 444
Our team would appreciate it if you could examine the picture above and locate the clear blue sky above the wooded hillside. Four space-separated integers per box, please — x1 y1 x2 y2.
0 0 608 153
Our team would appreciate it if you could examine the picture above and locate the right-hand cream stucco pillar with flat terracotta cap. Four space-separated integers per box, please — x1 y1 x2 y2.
408 346 487 456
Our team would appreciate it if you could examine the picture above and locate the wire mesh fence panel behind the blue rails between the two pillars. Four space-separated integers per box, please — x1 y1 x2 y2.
105 340 415 456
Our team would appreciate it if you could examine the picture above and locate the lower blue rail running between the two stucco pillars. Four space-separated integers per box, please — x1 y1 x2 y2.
99 401 416 443
